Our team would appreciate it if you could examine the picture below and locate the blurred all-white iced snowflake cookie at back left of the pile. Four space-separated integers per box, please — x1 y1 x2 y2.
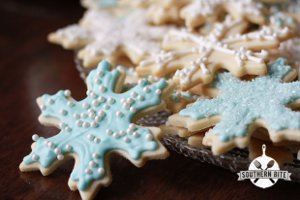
48 10 171 67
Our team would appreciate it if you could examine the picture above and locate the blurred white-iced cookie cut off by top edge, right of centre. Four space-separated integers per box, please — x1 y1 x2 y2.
144 0 265 29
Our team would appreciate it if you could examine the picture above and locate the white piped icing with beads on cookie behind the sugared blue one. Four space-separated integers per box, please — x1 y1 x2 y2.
140 24 290 88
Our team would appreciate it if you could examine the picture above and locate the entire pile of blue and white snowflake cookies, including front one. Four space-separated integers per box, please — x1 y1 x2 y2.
20 0 300 199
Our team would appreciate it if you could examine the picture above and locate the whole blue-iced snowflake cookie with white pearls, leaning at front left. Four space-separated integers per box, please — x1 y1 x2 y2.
20 61 168 199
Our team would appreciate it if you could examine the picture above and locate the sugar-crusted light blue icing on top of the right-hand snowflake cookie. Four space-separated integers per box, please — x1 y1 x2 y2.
179 58 300 142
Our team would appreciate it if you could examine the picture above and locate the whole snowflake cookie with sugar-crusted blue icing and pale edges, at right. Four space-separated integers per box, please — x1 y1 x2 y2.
169 59 300 154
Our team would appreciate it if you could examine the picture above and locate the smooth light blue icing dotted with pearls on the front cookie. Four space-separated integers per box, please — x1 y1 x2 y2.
23 61 167 190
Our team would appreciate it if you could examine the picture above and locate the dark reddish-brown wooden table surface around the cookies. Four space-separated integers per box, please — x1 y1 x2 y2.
0 0 300 200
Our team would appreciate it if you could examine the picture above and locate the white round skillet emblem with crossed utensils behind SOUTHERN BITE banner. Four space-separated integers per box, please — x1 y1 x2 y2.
249 145 280 188
